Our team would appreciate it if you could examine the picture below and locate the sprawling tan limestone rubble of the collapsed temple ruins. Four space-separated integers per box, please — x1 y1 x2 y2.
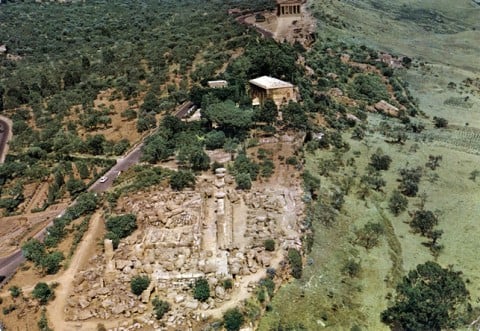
66 168 303 330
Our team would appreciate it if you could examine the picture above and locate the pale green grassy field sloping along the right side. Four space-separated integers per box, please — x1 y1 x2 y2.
259 0 480 330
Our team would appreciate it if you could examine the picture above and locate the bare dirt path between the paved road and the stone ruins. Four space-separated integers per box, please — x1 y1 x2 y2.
47 212 103 330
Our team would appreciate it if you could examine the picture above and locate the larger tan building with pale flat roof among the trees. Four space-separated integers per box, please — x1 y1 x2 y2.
249 76 297 108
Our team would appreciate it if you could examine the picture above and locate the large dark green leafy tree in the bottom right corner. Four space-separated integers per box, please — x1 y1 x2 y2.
381 261 471 331
